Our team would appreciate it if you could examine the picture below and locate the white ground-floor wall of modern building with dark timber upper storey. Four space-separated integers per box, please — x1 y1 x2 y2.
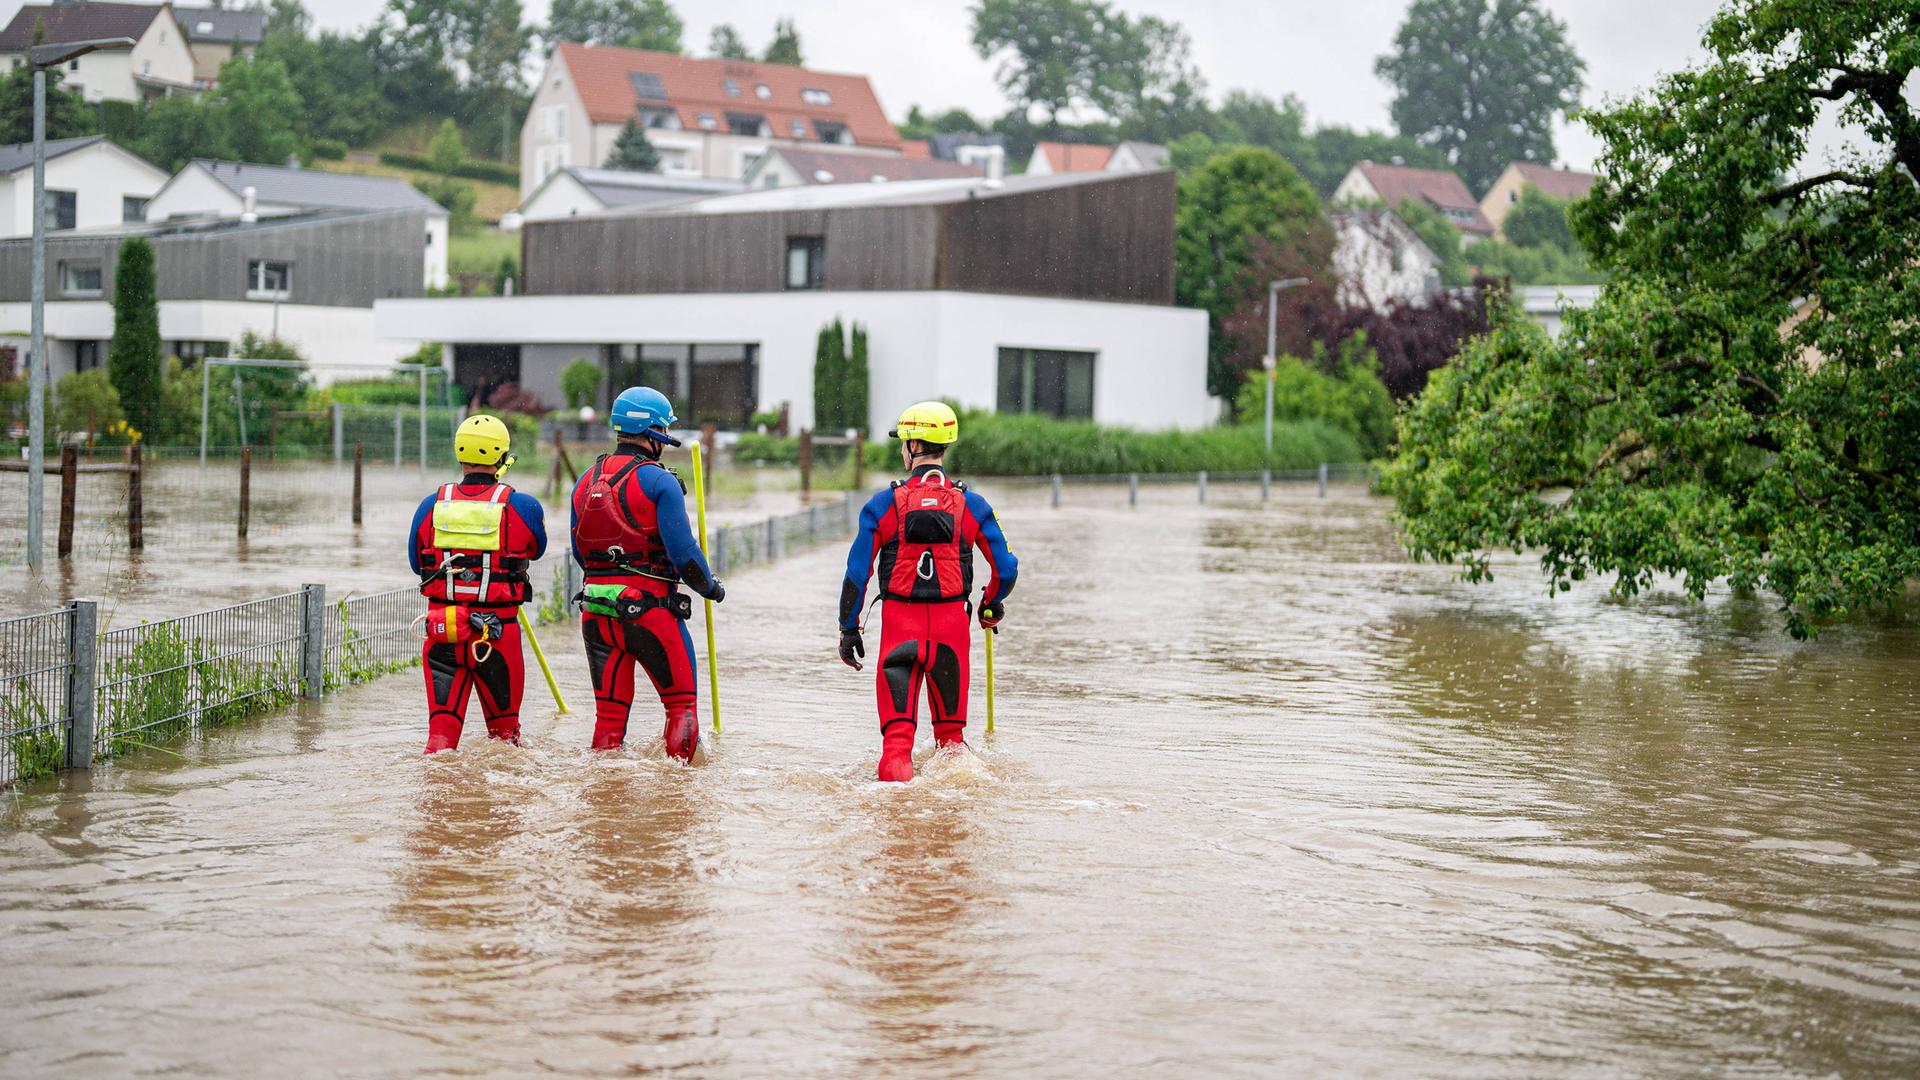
374 292 1217 430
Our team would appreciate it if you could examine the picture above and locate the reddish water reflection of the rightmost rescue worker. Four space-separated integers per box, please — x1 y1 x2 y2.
849 767 995 1070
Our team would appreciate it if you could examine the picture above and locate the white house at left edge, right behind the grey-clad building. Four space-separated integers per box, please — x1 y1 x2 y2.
0 135 167 236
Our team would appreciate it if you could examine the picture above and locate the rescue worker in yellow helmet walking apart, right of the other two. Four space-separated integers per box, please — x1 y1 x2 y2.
839 402 1020 780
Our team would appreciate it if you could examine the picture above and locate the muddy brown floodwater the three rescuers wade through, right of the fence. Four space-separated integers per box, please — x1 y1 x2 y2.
0 482 1920 1076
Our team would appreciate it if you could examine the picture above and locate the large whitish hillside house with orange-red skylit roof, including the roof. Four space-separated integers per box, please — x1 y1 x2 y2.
520 42 900 194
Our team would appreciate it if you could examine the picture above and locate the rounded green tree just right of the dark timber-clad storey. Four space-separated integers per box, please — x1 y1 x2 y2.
1173 146 1332 402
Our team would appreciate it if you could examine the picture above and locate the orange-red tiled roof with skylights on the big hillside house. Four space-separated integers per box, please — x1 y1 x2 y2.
555 42 900 148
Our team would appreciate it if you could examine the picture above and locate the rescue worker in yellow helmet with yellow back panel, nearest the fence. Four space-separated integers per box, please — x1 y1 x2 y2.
407 409 547 753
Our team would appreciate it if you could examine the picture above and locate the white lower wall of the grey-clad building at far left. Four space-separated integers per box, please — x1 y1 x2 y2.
0 300 420 379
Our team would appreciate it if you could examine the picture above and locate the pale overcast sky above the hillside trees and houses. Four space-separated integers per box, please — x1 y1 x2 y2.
307 0 1720 167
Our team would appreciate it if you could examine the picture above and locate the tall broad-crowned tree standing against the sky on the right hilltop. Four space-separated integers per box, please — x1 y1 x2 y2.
1375 0 1586 192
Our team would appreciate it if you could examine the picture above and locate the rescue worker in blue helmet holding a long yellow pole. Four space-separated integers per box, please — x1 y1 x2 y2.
572 386 726 761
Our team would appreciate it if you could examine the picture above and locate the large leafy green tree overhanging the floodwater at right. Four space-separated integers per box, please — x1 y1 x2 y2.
1388 0 1920 636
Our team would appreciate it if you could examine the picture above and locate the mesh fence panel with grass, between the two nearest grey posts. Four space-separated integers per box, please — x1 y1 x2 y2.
94 592 305 755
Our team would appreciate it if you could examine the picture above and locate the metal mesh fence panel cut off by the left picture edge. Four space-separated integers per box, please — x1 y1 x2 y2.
0 609 73 784
